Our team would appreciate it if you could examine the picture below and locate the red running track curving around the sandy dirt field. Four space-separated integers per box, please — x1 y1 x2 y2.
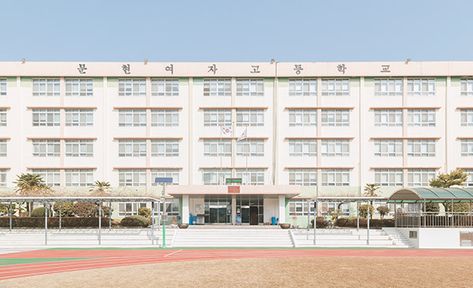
0 249 473 280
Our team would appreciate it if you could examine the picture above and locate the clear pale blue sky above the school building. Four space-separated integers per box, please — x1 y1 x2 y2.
0 0 473 61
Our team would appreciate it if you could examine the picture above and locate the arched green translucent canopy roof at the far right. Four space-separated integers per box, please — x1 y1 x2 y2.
388 187 473 203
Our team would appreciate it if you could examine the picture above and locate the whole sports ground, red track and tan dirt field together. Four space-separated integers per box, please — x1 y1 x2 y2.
0 249 473 288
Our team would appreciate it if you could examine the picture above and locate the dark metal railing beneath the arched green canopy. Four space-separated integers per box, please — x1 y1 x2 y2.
396 212 473 228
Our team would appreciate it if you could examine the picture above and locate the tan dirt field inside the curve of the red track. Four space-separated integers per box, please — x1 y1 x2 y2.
0 257 473 288
